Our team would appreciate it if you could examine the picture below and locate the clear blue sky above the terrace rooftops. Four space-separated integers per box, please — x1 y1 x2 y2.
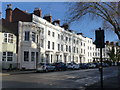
2 2 117 41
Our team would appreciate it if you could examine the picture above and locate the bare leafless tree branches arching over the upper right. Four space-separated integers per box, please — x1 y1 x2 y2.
68 2 120 40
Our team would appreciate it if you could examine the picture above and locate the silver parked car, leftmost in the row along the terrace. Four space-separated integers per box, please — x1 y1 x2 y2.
37 63 55 72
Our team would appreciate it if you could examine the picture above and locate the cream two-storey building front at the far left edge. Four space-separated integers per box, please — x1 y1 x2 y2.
0 32 17 69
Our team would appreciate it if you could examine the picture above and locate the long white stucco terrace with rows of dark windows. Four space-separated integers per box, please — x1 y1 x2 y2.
18 15 95 69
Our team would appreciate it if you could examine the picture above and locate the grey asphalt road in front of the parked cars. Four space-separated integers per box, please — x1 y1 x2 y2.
2 67 118 88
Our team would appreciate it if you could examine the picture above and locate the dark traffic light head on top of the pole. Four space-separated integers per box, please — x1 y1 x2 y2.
95 28 105 48
